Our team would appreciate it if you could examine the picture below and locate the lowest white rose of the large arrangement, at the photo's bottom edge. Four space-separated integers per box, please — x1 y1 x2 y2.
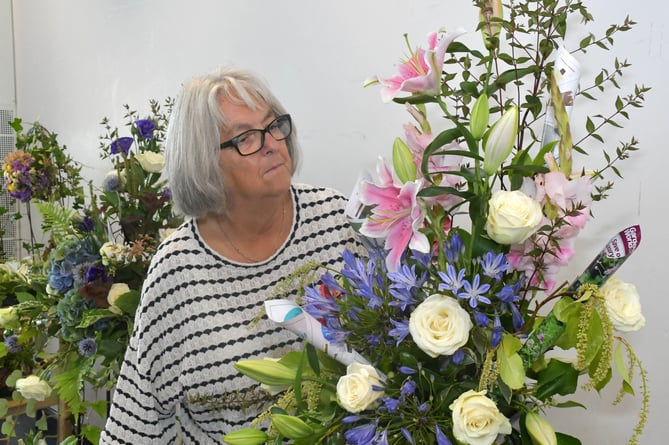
449 389 511 445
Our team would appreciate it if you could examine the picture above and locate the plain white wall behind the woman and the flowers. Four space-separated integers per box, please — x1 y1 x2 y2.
6 0 669 444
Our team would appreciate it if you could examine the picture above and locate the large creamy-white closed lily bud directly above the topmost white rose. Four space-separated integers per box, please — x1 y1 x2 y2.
483 106 518 176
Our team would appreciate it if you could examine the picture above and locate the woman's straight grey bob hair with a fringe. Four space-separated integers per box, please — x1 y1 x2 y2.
165 67 299 218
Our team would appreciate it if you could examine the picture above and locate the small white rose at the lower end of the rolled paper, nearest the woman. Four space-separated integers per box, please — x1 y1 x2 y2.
337 362 383 413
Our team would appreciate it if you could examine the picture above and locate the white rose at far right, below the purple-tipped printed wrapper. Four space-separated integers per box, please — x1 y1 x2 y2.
600 277 646 332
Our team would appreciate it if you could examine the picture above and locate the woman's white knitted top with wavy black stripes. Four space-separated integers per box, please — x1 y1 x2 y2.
100 184 359 445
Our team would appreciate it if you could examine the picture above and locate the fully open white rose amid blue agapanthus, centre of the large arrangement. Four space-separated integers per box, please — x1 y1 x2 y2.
409 294 472 357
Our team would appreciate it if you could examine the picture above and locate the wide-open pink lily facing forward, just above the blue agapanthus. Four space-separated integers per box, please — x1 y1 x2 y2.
360 162 430 271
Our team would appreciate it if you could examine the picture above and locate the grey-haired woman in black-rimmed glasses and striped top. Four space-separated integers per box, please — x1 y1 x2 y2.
100 68 359 445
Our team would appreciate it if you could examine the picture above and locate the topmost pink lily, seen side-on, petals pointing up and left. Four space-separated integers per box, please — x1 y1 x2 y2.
375 30 464 102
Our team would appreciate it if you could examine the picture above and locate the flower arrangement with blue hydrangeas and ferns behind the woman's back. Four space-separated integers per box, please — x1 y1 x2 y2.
0 98 181 443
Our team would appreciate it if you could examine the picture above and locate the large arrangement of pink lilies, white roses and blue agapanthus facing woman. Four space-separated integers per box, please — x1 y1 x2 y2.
228 0 649 445
